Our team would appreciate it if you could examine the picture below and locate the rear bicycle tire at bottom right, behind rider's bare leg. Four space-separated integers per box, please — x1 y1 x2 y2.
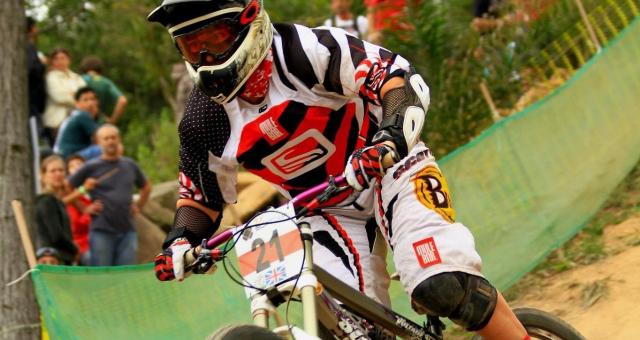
472 307 585 340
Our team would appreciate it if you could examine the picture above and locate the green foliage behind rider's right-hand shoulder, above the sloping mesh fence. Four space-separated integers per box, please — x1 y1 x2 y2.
385 0 612 156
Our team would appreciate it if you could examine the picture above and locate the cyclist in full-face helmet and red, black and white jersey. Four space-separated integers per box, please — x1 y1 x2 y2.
148 0 527 339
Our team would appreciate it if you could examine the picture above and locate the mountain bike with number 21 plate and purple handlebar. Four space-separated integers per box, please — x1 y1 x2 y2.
187 176 584 340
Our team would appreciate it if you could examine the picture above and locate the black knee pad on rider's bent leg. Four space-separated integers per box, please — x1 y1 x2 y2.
411 272 498 331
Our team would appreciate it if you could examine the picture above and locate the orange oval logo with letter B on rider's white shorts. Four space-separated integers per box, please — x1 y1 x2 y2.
413 165 456 223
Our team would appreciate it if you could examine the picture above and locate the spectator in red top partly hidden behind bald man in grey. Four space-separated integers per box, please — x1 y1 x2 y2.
67 155 102 265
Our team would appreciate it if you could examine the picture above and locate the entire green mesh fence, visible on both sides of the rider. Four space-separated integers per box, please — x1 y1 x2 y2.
33 19 640 339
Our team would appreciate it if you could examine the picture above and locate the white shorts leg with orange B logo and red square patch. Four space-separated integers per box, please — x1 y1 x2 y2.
375 143 482 295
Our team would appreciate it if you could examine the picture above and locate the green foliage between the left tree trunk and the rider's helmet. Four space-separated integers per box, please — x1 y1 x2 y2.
28 0 179 166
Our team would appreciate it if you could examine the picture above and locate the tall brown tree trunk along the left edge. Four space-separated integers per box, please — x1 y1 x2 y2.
0 0 40 340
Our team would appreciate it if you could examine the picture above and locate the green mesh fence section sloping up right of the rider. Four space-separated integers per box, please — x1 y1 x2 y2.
440 13 640 287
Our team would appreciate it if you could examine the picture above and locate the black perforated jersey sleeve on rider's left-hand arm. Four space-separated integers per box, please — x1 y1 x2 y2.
178 87 230 211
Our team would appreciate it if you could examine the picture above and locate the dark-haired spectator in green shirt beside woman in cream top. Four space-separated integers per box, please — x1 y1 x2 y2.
80 56 127 124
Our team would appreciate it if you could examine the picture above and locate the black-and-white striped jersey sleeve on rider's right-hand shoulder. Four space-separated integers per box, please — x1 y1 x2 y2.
275 24 411 105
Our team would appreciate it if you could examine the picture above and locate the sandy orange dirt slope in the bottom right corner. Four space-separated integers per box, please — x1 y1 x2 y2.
511 217 640 340
